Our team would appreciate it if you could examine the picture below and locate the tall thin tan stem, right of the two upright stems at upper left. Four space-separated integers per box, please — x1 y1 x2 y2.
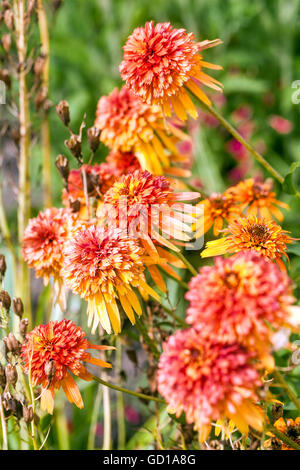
37 0 52 207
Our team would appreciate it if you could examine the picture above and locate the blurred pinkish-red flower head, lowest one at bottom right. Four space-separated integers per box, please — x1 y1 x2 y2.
157 328 263 441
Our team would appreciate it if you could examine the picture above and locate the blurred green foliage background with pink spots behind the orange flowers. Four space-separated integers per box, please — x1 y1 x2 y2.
1 0 300 449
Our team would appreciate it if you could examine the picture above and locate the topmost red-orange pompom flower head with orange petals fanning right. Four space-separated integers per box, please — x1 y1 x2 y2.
120 21 222 120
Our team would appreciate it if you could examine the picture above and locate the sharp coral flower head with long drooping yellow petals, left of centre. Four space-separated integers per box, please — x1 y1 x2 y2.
63 225 159 334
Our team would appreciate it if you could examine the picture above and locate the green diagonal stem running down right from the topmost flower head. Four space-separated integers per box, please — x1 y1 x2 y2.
200 101 284 184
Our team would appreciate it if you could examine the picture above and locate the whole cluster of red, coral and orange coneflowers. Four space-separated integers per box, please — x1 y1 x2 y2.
19 22 294 441
